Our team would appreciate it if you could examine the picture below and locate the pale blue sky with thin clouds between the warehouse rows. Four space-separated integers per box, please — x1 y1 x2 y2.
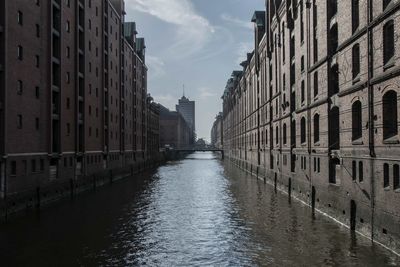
125 0 265 140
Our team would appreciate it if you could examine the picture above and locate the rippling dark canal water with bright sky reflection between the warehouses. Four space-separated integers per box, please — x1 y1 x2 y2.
0 153 400 266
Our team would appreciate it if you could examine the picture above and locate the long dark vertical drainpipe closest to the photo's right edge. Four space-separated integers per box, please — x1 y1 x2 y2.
367 0 376 240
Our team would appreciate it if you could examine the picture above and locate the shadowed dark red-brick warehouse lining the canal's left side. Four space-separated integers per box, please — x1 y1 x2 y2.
0 0 154 201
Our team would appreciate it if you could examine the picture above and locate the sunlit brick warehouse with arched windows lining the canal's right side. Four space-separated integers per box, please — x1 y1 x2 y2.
217 0 400 252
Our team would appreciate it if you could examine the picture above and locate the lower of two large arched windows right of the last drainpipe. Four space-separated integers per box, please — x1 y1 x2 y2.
382 91 398 139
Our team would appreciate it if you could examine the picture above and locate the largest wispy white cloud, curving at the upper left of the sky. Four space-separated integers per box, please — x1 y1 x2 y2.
126 0 215 58
